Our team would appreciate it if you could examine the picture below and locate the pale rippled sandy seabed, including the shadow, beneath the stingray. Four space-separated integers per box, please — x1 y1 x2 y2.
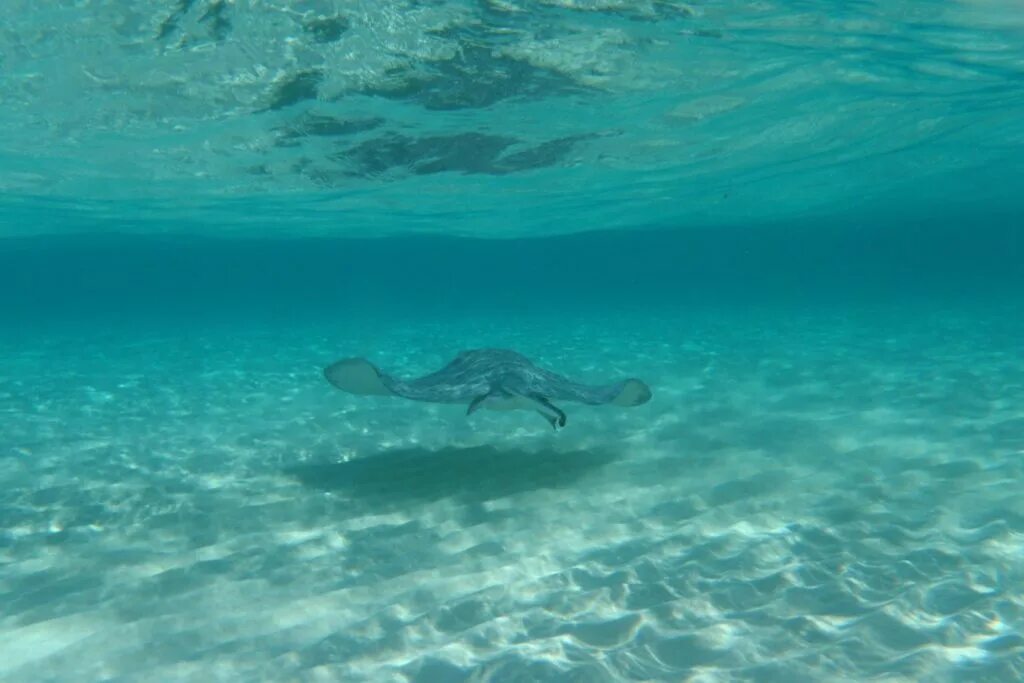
0 310 1024 683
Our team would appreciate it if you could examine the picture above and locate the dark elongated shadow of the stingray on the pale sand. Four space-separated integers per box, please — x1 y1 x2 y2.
286 445 617 507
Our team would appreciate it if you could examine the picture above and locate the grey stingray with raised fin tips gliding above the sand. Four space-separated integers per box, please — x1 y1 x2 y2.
324 349 651 430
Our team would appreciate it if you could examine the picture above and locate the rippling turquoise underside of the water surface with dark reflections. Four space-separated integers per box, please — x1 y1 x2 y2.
0 0 1024 238
